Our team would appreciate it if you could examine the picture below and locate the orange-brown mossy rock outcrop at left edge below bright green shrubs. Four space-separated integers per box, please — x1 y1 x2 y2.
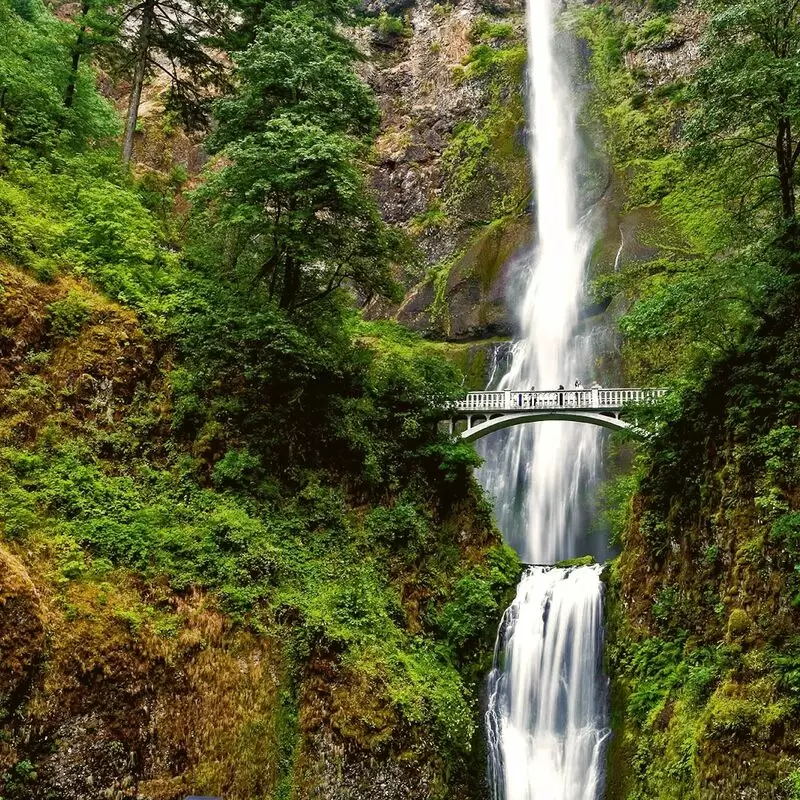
0 262 153 441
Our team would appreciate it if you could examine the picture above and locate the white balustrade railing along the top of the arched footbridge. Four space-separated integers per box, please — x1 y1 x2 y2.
455 388 667 414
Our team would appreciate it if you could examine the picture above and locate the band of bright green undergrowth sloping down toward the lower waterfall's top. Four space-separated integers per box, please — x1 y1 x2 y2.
0 432 518 748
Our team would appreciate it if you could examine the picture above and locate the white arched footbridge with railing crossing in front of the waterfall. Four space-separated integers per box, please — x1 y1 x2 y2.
448 388 667 442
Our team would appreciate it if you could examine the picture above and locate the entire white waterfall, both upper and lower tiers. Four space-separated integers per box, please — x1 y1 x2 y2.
478 0 607 800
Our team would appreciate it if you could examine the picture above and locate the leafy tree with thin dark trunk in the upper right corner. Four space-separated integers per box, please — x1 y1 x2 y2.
688 0 800 251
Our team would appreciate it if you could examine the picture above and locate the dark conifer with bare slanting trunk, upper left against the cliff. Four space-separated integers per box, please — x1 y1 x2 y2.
118 0 226 163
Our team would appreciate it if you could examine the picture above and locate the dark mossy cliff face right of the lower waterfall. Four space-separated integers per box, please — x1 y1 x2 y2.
606 304 800 800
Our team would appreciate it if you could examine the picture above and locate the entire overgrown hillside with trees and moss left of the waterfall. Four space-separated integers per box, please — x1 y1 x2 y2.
0 0 519 800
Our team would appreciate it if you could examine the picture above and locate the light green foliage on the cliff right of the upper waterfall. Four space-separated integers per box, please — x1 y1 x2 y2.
578 4 789 384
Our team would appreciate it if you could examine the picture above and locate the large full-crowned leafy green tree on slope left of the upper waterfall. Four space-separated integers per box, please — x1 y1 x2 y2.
197 12 403 312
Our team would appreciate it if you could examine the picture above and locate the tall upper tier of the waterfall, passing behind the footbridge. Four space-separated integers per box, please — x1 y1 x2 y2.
479 0 607 564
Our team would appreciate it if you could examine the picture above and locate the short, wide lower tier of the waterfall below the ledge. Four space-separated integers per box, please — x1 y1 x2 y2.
486 567 607 800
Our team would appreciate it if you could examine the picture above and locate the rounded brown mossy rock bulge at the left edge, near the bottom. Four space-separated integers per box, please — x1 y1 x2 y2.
0 547 45 716
